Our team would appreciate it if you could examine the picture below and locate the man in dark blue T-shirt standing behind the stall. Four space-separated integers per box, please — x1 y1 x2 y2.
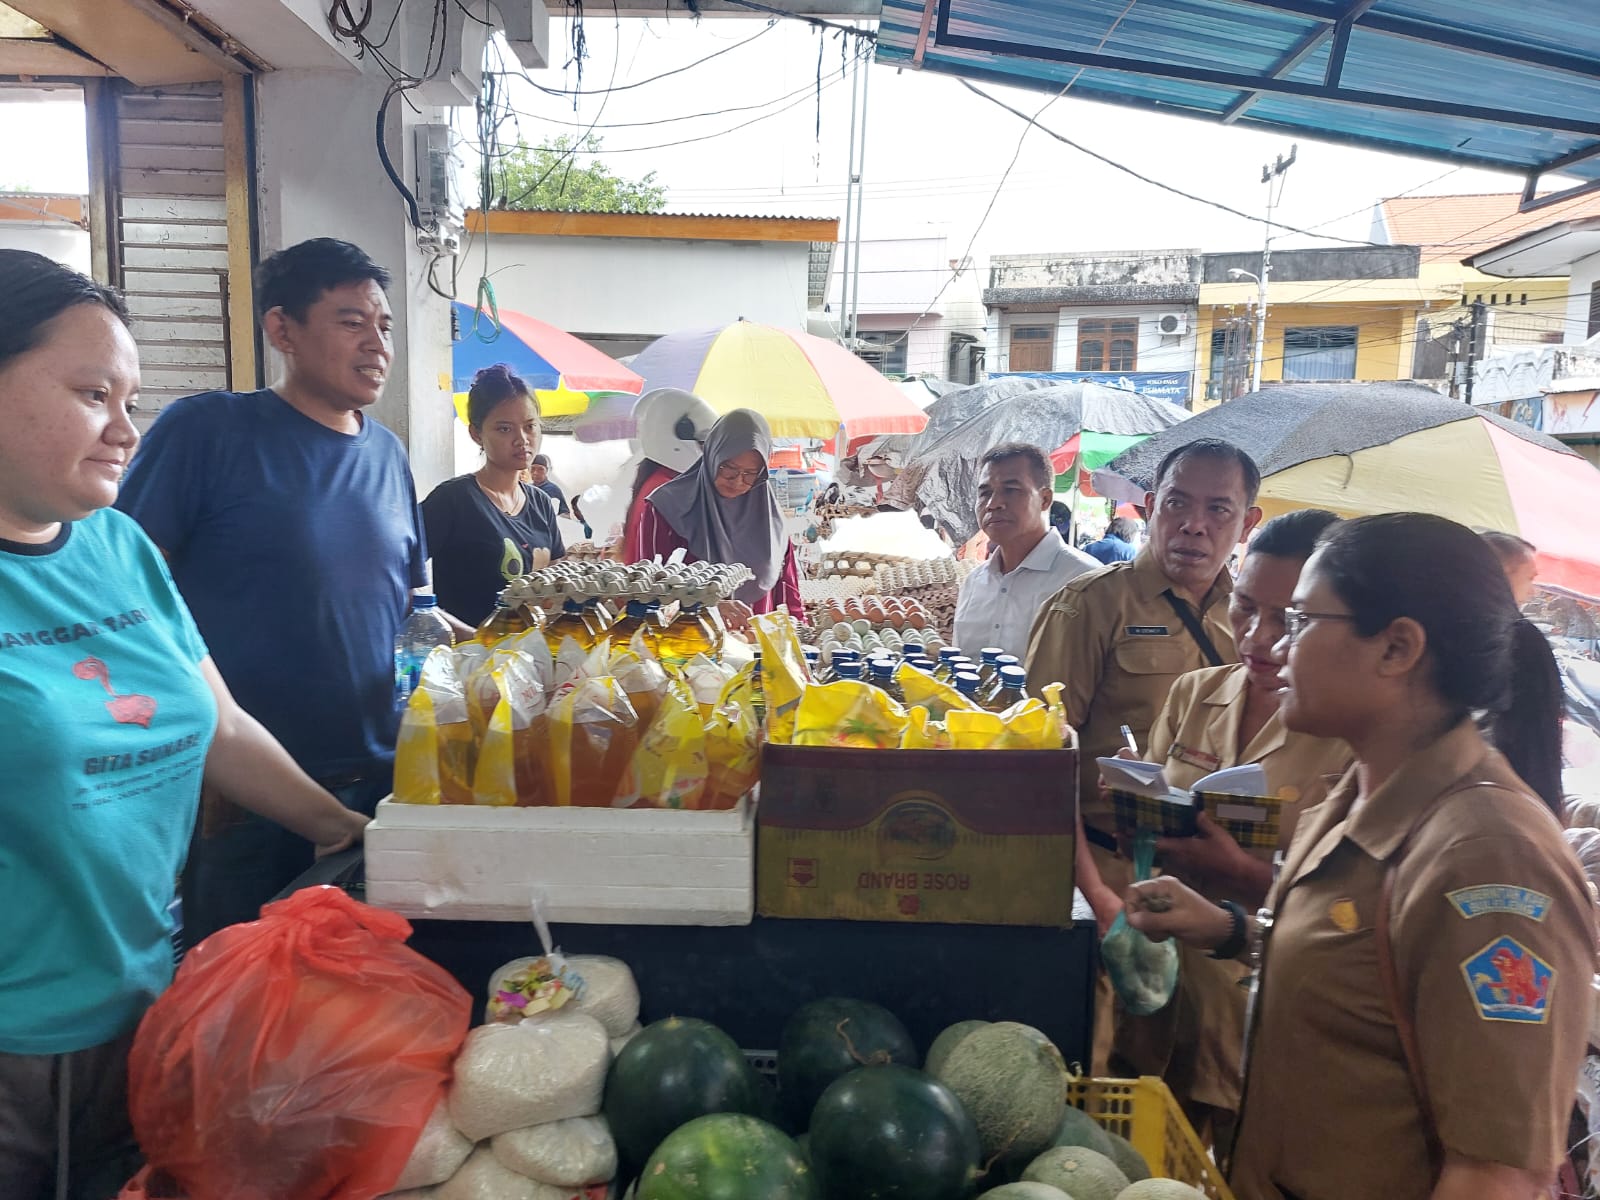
117 238 427 946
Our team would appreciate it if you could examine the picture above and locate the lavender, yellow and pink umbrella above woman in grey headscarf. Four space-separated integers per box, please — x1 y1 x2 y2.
574 320 928 442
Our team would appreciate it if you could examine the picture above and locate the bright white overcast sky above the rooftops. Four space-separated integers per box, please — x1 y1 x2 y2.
0 14 1548 261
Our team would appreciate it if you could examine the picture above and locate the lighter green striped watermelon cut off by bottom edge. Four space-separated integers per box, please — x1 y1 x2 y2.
638 1112 822 1200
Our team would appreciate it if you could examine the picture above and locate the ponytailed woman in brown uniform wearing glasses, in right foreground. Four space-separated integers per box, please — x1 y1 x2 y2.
1126 514 1595 1200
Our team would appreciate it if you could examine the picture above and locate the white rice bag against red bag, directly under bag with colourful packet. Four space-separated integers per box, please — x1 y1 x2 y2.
450 1013 611 1142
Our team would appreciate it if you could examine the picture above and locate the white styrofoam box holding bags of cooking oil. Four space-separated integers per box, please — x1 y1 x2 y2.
366 798 755 925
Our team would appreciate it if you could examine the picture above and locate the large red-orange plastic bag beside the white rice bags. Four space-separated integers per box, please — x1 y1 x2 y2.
128 888 472 1200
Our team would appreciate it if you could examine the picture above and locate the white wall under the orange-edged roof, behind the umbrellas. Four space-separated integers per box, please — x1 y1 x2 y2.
473 234 811 336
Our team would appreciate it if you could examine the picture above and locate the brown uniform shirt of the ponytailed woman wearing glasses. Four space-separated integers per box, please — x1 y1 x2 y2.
1232 722 1595 1200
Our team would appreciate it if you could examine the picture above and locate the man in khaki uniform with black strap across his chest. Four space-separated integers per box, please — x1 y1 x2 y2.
1027 438 1261 1074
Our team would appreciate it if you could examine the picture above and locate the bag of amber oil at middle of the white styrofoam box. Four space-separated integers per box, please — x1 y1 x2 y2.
549 675 638 808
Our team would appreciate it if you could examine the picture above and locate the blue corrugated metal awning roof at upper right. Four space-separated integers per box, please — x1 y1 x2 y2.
877 0 1600 197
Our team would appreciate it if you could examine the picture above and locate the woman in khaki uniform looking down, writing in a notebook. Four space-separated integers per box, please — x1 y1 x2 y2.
1114 509 1352 1149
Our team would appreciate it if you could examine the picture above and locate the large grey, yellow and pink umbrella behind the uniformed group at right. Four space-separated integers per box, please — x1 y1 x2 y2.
1093 382 1600 597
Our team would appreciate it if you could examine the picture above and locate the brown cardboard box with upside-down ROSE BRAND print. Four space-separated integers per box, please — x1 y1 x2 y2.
755 746 1078 928
